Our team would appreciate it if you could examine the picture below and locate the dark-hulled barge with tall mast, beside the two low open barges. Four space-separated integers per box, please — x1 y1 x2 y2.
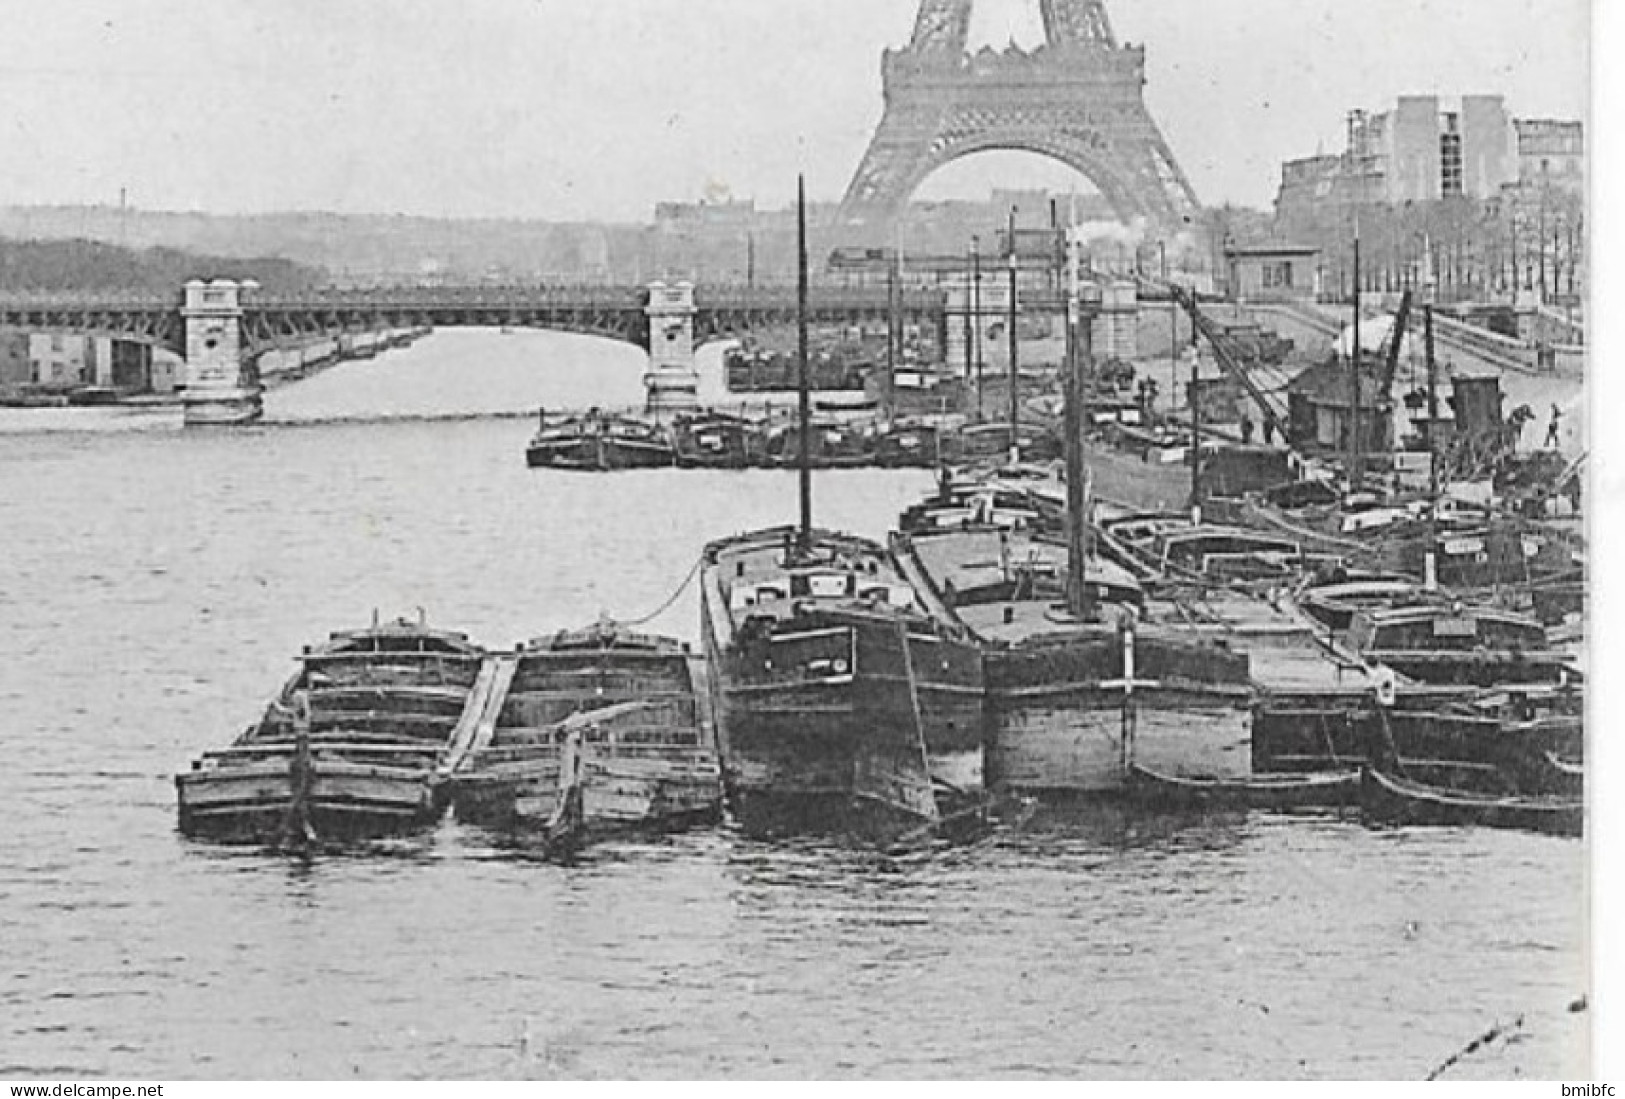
700 527 982 834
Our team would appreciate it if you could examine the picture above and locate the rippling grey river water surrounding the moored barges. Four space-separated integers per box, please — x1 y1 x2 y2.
0 333 1586 1078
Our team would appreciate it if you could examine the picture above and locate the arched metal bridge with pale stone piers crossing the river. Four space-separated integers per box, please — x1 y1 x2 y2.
0 273 1560 424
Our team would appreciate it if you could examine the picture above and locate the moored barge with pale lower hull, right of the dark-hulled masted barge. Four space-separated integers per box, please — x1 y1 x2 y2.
894 507 1253 795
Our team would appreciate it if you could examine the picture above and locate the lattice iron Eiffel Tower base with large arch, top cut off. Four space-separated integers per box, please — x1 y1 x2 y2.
840 0 1199 244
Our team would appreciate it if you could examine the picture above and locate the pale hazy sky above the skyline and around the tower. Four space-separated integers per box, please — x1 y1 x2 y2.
0 0 1589 221
